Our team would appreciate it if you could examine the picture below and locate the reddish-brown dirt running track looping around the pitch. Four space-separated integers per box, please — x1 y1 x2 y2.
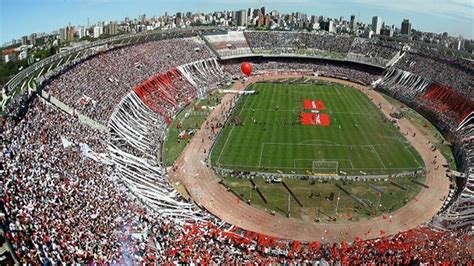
169 76 450 242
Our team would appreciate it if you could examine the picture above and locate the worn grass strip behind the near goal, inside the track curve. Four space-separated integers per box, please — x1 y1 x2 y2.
222 176 425 221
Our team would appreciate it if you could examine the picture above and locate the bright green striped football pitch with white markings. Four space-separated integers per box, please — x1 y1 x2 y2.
211 81 424 176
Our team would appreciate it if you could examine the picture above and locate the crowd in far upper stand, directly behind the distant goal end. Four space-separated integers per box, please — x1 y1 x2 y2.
244 31 353 57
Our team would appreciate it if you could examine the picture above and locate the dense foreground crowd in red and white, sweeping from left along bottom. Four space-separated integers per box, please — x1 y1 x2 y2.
2 96 472 264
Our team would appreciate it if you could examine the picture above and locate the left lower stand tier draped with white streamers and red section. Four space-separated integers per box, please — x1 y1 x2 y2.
109 59 225 219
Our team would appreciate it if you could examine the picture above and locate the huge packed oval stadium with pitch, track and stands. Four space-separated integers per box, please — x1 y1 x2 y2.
2 26 474 264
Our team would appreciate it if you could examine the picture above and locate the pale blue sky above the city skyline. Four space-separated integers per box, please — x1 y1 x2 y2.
0 0 474 44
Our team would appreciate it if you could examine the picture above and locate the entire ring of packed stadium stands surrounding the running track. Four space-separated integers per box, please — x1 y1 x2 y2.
0 29 474 264
